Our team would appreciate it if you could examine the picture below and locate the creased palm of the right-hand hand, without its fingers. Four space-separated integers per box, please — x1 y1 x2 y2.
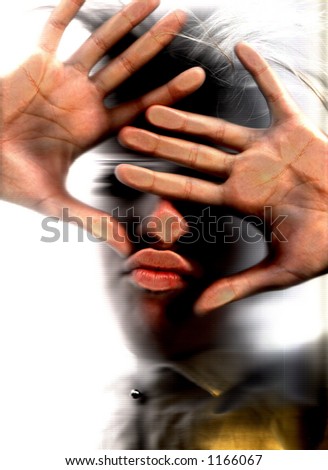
225 115 328 283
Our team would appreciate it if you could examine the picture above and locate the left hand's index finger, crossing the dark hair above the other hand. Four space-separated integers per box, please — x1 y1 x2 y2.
108 67 205 130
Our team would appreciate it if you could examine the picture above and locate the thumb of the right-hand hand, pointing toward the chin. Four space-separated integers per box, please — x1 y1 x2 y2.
194 260 300 315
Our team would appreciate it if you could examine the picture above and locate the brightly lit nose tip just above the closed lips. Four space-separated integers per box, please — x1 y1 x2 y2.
141 199 188 250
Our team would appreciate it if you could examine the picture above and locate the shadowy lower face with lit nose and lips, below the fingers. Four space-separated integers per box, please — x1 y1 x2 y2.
92 157 263 359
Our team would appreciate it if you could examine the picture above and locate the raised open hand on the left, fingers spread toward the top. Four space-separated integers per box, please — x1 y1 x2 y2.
0 0 204 253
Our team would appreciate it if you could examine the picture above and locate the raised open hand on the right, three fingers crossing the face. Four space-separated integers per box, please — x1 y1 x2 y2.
117 43 328 314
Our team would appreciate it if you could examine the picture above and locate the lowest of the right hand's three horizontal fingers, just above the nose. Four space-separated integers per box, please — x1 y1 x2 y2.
115 164 224 204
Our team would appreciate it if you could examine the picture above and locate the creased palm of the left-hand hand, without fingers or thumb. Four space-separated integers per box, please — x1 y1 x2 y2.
2 51 100 208
